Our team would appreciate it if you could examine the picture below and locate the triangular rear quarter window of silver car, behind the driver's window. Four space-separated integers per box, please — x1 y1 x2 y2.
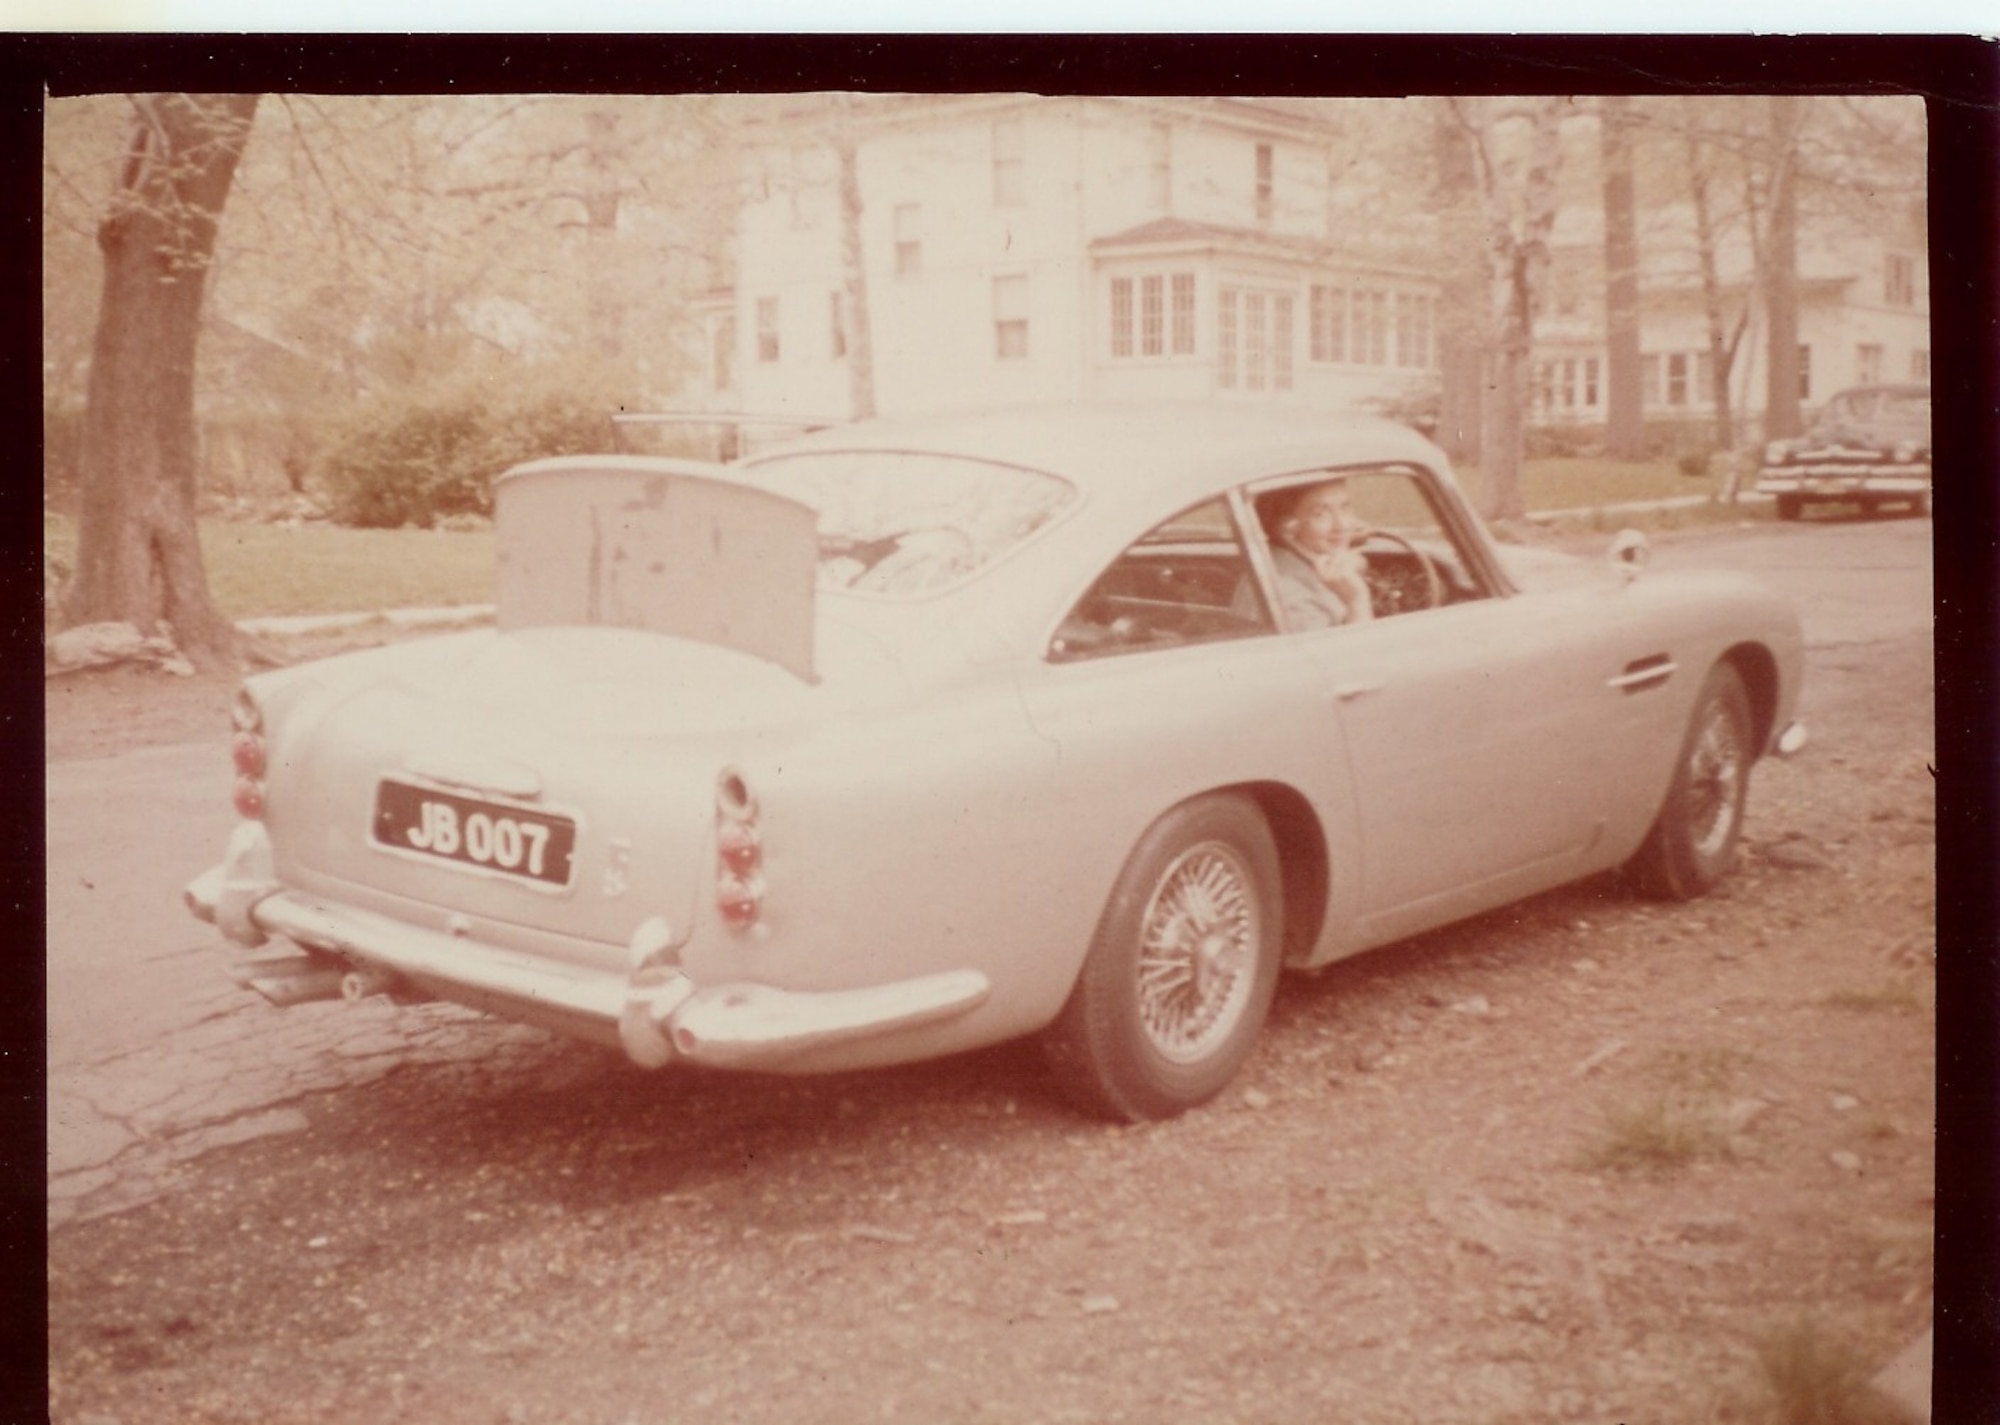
1048 498 1276 662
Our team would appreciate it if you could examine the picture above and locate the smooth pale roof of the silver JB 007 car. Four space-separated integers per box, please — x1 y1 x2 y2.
736 402 1448 520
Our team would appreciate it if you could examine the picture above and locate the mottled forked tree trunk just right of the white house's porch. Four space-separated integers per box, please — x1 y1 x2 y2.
1450 96 1568 522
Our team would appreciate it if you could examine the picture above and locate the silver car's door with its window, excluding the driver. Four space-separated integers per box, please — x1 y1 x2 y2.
1260 466 1620 943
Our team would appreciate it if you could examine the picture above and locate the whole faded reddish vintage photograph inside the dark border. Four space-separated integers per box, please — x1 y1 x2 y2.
42 88 1936 1425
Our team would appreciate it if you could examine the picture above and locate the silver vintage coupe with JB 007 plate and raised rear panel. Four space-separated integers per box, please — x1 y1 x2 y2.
186 404 1802 1119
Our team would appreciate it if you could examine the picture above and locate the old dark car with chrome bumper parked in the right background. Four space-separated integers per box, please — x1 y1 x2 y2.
1756 384 1930 520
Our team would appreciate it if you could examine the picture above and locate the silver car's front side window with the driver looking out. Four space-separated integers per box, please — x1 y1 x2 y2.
1252 466 1492 630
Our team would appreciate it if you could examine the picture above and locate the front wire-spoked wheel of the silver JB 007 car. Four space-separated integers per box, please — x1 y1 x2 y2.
1626 662 1756 901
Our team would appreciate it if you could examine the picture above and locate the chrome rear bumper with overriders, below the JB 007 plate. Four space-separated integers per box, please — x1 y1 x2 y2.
184 823 992 1069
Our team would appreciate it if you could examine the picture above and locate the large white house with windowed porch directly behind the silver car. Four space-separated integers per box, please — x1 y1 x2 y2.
704 94 1440 416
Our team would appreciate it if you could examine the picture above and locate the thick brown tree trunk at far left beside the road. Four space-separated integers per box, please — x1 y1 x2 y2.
62 94 258 668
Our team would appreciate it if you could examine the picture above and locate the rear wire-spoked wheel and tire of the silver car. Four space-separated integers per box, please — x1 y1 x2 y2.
1044 795 1284 1123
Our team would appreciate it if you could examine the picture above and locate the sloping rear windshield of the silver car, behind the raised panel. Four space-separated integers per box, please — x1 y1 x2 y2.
752 450 1076 596
